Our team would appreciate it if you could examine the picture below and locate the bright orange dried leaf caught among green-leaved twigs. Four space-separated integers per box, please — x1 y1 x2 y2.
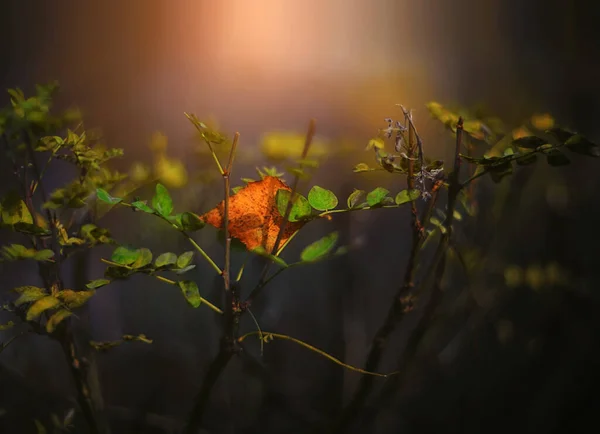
200 176 305 252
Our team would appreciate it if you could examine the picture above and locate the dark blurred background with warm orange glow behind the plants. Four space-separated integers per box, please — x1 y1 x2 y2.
0 0 600 433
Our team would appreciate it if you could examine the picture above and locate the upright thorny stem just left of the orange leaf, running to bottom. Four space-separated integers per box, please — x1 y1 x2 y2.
185 133 241 434
